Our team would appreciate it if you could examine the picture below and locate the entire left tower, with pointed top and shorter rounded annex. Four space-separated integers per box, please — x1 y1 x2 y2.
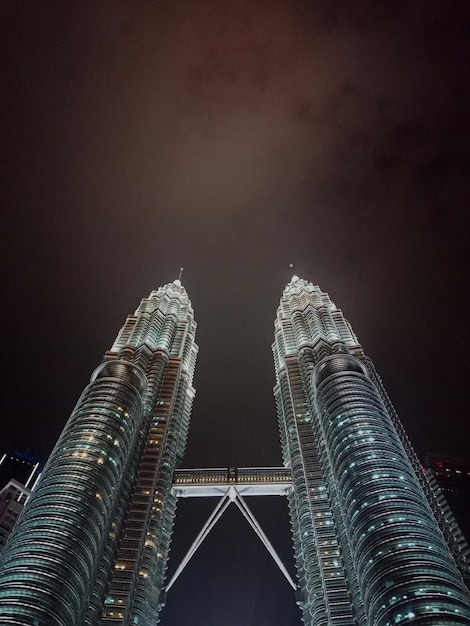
0 280 197 626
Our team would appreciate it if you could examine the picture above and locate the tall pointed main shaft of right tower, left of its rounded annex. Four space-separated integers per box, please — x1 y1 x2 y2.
273 278 361 626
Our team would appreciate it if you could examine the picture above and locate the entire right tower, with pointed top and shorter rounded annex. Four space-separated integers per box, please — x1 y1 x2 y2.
273 276 470 626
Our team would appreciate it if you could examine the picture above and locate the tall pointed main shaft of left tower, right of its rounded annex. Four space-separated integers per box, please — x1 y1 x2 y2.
96 281 197 626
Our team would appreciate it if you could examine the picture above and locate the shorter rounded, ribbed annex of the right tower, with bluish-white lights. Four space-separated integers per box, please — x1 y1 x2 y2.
314 354 470 626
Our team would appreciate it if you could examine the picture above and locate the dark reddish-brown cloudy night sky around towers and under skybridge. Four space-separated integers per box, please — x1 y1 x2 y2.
0 0 470 626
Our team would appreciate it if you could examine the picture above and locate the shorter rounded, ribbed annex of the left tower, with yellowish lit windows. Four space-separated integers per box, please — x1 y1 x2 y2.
0 361 146 626
